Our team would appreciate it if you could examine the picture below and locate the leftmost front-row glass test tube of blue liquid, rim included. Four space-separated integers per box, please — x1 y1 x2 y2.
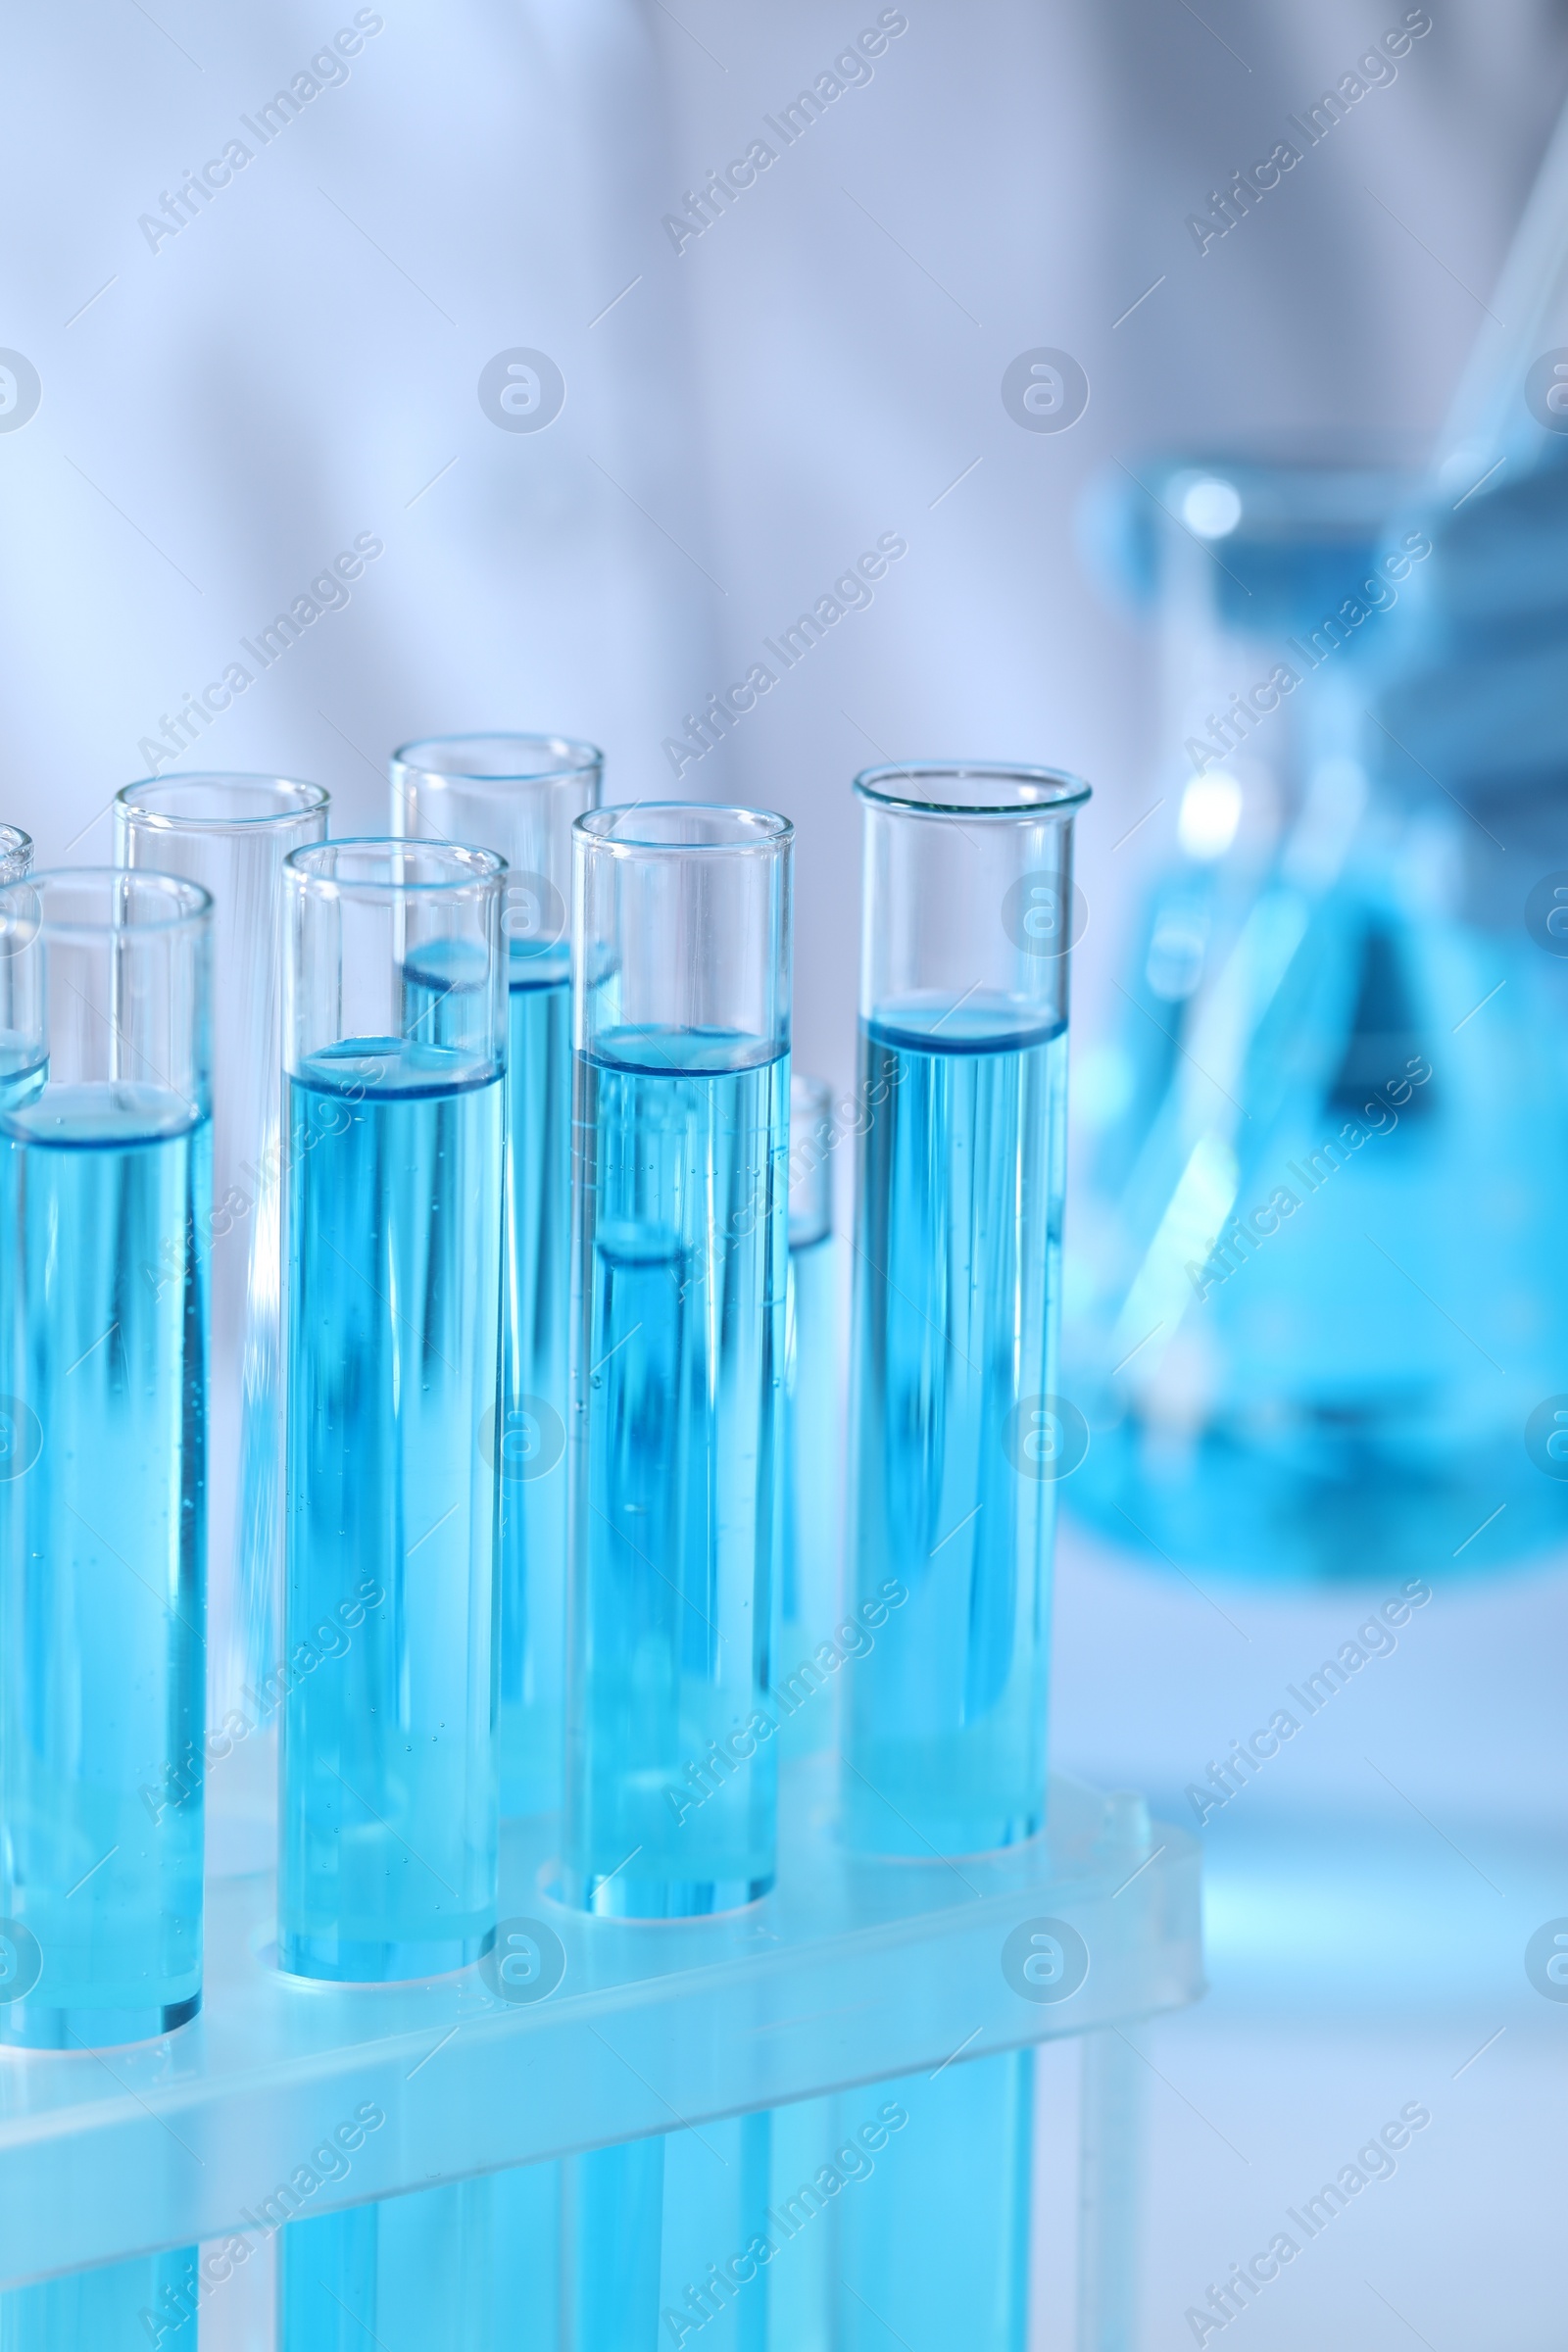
0 868 212 2048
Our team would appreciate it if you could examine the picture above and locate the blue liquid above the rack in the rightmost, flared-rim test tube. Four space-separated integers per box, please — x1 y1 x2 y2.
844 998 1067 1853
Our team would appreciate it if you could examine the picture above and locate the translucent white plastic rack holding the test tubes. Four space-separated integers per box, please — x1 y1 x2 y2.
0 1757 1201 2352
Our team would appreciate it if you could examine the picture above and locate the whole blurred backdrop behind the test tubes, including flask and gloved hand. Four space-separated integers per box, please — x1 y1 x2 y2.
0 0 1568 2352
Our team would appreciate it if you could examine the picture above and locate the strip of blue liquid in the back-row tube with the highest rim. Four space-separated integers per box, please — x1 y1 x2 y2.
496 957 571 1813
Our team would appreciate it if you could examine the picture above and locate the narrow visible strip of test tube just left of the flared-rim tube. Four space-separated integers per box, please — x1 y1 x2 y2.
773 1070 841 1757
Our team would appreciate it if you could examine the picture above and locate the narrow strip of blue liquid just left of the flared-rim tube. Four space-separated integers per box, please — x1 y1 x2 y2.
778 1233 844 1757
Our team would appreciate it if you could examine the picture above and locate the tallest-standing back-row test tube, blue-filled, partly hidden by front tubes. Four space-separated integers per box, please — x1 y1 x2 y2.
393 734 604 1813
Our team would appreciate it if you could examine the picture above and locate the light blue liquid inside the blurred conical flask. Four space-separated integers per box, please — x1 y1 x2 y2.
1081 889 1568 1590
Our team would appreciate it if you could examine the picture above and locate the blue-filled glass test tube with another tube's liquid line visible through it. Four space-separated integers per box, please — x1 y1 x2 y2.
566 802 790 1917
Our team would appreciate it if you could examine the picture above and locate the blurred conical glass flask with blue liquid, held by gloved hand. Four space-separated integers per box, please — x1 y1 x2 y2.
1065 449 1568 1583
